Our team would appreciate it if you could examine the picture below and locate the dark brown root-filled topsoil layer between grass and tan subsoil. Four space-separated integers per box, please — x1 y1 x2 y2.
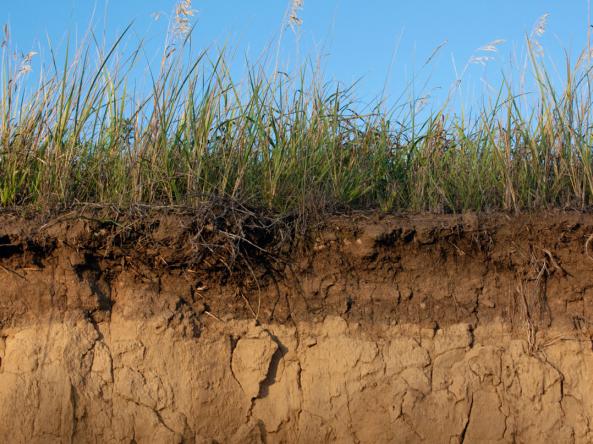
0 205 593 334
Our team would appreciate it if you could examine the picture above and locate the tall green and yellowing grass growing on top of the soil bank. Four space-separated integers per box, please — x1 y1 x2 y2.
0 22 593 214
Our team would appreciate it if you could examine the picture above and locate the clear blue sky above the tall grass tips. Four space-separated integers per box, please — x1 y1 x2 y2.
0 0 588 110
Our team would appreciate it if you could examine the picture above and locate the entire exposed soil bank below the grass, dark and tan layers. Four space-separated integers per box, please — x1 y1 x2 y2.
0 211 593 443
